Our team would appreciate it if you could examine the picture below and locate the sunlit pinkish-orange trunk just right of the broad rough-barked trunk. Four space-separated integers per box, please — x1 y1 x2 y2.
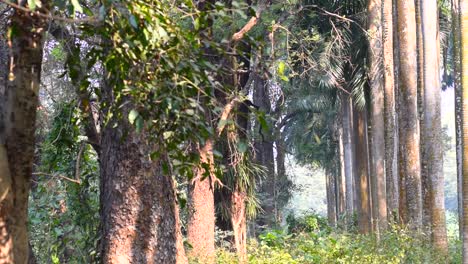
187 139 216 263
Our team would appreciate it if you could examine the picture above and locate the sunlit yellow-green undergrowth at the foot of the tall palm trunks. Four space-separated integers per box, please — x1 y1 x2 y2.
193 214 461 264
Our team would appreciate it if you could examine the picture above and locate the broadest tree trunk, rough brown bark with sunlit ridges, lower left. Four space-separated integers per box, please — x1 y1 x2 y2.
100 102 187 264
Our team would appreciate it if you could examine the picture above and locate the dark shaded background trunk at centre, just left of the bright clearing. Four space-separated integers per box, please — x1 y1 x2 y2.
253 74 277 228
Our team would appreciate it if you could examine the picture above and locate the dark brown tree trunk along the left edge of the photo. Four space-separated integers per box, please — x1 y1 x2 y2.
0 5 50 263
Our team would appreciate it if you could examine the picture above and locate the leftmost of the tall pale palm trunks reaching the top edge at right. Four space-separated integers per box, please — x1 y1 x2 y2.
368 0 387 237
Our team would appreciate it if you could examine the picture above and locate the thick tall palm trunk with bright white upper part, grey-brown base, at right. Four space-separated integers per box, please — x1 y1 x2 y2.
420 0 448 254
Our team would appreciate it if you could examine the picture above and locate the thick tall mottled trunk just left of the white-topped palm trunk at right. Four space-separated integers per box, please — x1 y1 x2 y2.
397 0 422 229
